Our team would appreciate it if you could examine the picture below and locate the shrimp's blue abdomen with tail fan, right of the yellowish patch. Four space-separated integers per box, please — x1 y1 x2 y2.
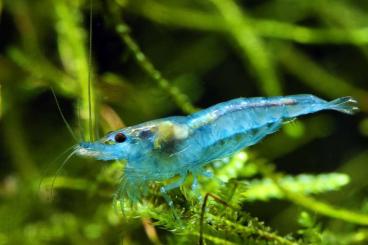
188 94 358 164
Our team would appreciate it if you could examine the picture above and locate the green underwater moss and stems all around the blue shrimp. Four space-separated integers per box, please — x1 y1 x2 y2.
0 0 368 244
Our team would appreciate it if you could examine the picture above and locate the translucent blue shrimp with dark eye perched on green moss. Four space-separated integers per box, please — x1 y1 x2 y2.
76 94 358 207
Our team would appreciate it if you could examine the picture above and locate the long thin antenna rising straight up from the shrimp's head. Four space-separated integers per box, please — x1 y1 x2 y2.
88 0 94 141
